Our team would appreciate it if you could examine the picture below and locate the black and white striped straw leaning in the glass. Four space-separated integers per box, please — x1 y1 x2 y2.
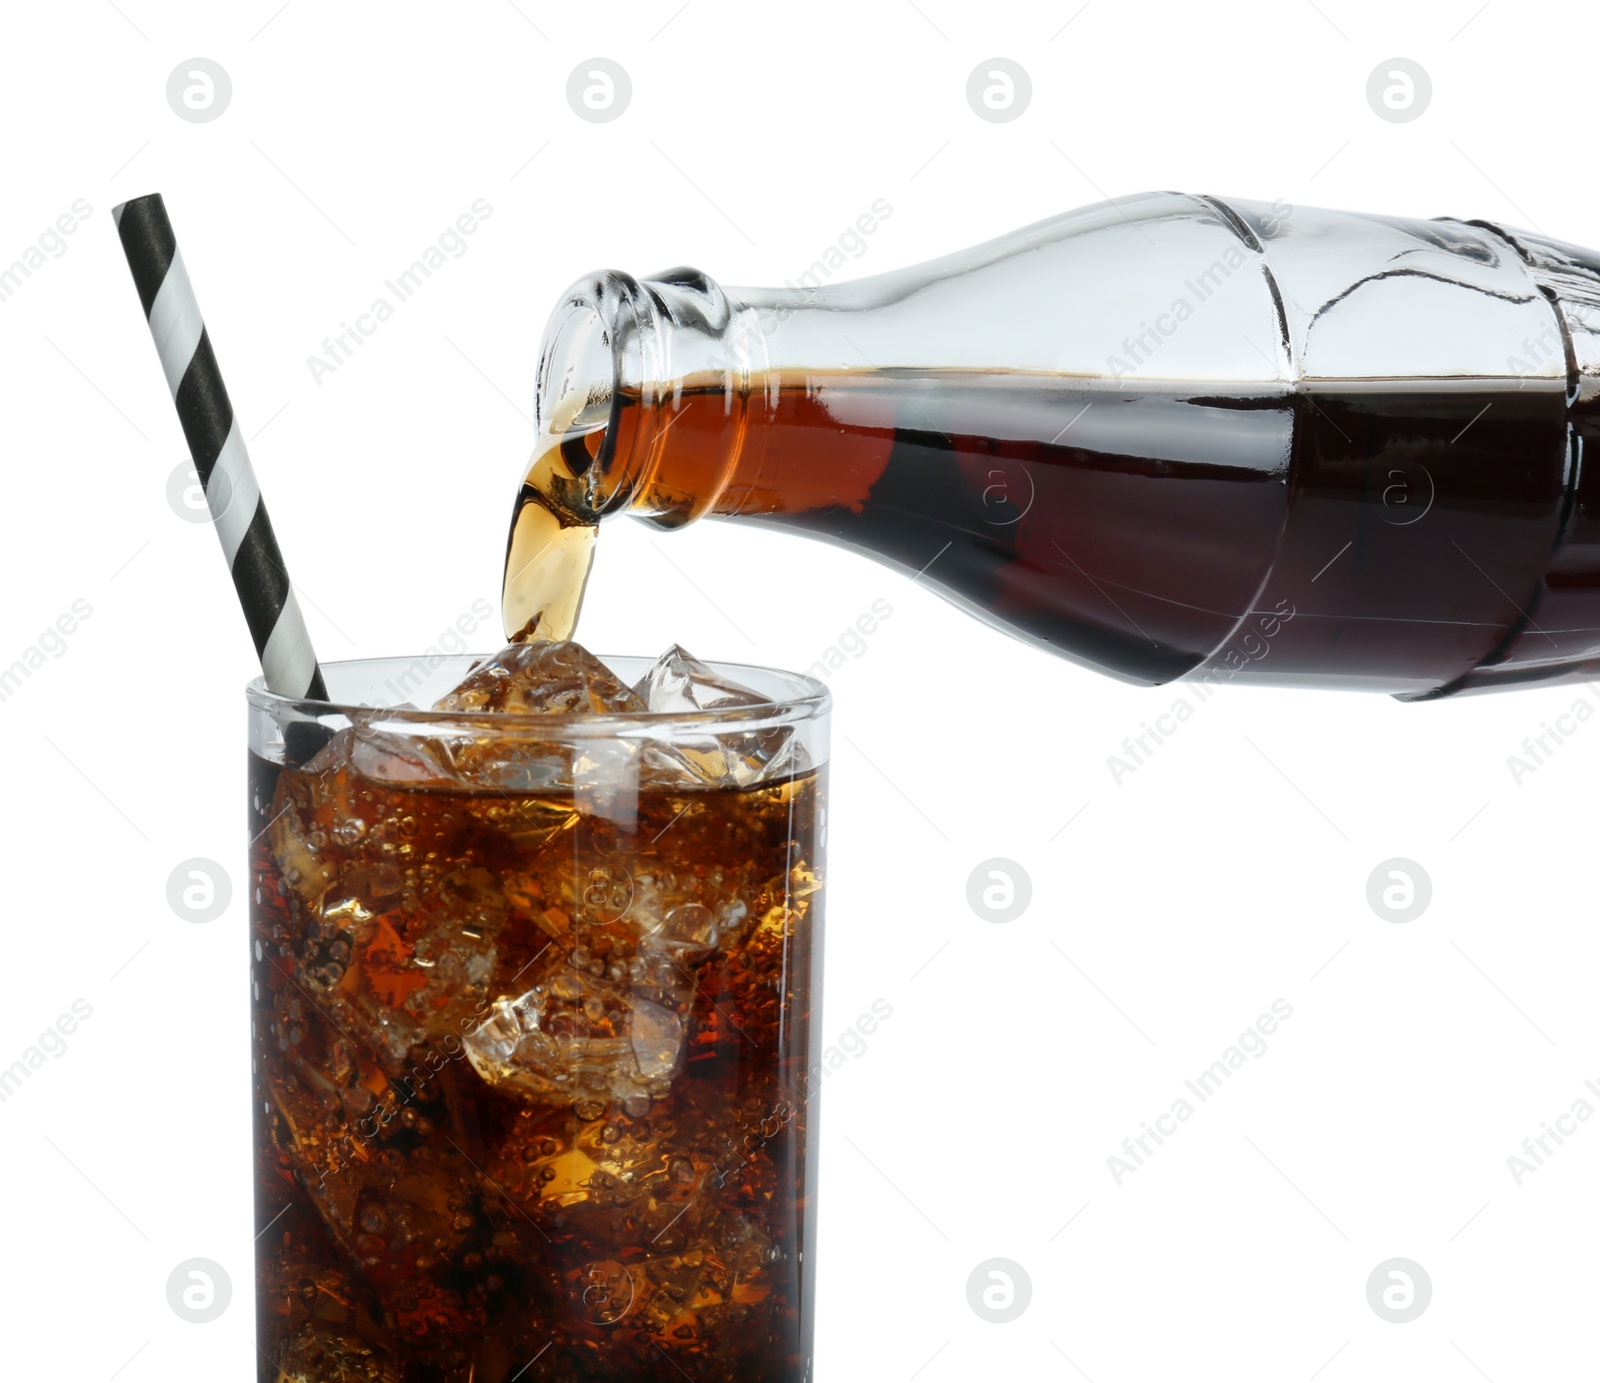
112 192 328 701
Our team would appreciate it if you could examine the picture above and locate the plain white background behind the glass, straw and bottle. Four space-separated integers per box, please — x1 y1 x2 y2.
0 0 1600 1383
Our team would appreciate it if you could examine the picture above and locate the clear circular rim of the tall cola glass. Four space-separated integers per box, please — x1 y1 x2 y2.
245 650 834 738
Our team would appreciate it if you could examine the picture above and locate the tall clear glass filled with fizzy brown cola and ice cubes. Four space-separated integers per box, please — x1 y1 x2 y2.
248 656 829 1383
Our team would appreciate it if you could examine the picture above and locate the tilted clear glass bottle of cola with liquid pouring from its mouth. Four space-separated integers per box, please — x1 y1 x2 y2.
504 192 1600 700
